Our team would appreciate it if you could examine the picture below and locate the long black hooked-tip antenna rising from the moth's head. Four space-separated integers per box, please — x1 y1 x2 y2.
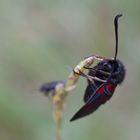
114 14 122 60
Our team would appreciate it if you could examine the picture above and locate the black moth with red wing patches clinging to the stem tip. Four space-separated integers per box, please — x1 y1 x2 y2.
70 14 125 121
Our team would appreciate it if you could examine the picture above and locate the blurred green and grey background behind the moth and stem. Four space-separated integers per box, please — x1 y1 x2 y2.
0 0 140 140
